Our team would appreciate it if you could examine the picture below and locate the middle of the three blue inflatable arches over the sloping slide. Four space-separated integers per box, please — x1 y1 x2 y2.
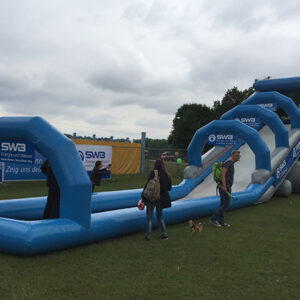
221 105 289 148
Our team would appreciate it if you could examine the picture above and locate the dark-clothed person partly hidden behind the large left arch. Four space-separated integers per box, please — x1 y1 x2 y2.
41 159 60 219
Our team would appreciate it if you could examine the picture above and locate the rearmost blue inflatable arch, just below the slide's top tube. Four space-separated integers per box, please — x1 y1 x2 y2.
242 92 300 129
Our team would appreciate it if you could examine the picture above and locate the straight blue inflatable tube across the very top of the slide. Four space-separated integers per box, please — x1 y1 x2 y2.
253 77 300 93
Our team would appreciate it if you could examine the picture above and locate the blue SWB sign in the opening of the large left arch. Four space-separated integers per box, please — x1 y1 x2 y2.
0 141 35 164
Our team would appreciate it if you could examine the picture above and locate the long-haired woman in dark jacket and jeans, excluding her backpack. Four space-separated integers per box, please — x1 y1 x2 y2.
142 159 172 241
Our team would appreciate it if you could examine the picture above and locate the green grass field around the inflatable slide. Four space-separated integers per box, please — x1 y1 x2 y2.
0 168 300 299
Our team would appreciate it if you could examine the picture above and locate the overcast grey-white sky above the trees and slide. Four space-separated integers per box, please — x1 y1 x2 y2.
0 0 300 138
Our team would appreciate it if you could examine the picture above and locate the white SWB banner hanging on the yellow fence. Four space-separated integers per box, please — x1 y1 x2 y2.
76 144 112 171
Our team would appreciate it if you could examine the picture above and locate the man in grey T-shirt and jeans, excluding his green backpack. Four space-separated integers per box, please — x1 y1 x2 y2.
209 150 241 227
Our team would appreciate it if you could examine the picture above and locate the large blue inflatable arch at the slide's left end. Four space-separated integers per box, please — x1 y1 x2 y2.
0 117 92 228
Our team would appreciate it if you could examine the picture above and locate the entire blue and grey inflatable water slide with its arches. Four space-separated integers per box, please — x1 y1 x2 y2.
0 77 300 255
